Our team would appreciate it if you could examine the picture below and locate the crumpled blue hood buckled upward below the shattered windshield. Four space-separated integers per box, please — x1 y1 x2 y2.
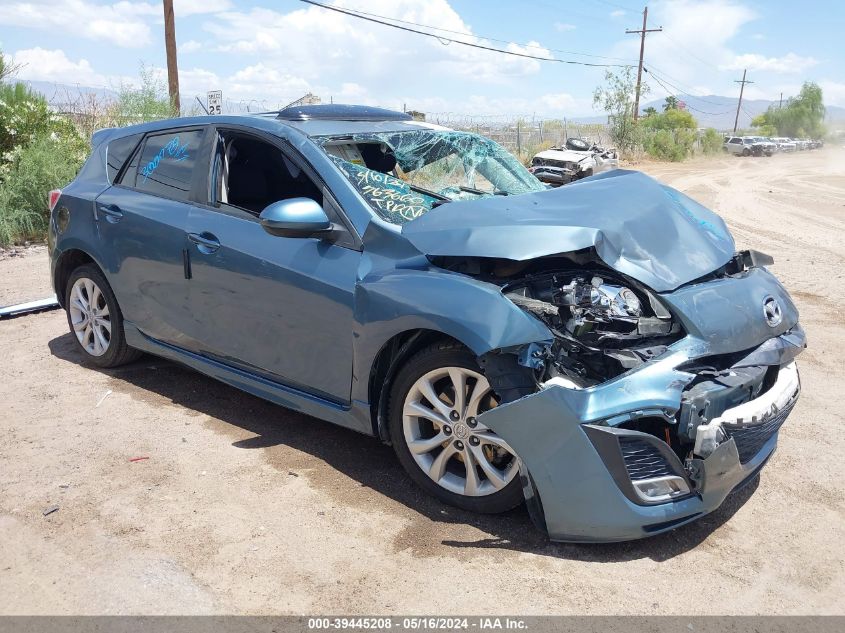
402 169 735 292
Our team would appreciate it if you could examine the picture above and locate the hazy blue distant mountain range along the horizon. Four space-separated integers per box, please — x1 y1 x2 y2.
16 79 845 130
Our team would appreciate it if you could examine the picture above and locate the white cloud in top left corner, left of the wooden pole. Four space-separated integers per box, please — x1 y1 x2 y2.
0 0 151 48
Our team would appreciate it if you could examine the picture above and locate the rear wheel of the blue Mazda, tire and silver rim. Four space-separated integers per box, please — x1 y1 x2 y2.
65 264 141 367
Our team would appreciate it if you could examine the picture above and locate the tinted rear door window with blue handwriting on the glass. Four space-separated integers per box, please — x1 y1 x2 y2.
129 130 203 200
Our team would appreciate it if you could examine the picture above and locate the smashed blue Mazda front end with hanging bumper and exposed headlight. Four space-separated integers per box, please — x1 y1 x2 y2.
474 256 805 541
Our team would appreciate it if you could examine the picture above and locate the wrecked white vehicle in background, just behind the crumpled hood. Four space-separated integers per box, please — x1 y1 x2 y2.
528 138 619 186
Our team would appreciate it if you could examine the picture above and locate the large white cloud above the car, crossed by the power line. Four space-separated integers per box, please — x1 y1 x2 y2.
204 0 550 82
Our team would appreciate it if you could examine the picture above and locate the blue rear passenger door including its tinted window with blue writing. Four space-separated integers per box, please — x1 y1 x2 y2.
95 126 207 346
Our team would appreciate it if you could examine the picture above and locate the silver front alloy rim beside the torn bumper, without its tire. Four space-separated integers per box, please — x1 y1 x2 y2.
402 367 519 497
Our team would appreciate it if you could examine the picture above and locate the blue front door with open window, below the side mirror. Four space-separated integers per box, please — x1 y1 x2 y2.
186 130 361 402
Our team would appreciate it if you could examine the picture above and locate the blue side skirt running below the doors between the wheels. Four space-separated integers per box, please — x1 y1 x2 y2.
123 321 373 435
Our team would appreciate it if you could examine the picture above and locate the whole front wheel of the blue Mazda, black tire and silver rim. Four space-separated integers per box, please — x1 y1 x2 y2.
389 342 523 514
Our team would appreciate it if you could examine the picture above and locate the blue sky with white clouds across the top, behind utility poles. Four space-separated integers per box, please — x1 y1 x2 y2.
0 0 845 117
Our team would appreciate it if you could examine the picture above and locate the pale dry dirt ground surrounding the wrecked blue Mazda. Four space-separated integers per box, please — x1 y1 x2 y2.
0 148 845 614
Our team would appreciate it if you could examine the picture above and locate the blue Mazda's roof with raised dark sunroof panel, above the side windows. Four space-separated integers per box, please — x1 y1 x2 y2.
92 104 449 146
